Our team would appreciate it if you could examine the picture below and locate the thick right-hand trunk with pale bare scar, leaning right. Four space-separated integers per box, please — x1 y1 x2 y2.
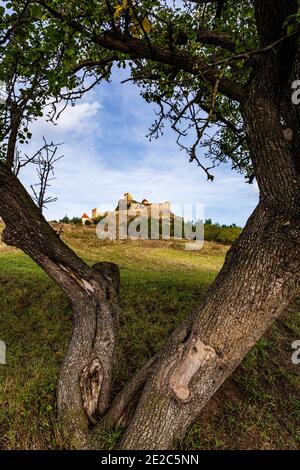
112 70 300 449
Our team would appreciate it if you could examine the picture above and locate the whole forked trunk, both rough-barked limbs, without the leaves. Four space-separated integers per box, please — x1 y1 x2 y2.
0 0 300 449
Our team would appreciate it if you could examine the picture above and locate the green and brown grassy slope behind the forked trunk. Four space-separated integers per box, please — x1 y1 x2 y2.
0 226 300 449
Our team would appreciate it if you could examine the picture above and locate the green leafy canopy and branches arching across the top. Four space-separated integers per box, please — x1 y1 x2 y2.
0 0 298 181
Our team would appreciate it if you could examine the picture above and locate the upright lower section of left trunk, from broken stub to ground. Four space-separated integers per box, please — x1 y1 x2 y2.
57 262 120 448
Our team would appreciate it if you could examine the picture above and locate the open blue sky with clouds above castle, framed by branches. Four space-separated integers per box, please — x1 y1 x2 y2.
21 69 258 225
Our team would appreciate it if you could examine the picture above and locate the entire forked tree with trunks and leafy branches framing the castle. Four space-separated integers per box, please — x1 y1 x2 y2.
0 0 300 449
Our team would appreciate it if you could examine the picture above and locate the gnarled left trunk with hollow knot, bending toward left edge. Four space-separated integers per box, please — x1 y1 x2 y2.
0 163 119 447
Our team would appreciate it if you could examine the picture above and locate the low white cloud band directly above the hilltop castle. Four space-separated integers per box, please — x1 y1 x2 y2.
26 137 257 224
